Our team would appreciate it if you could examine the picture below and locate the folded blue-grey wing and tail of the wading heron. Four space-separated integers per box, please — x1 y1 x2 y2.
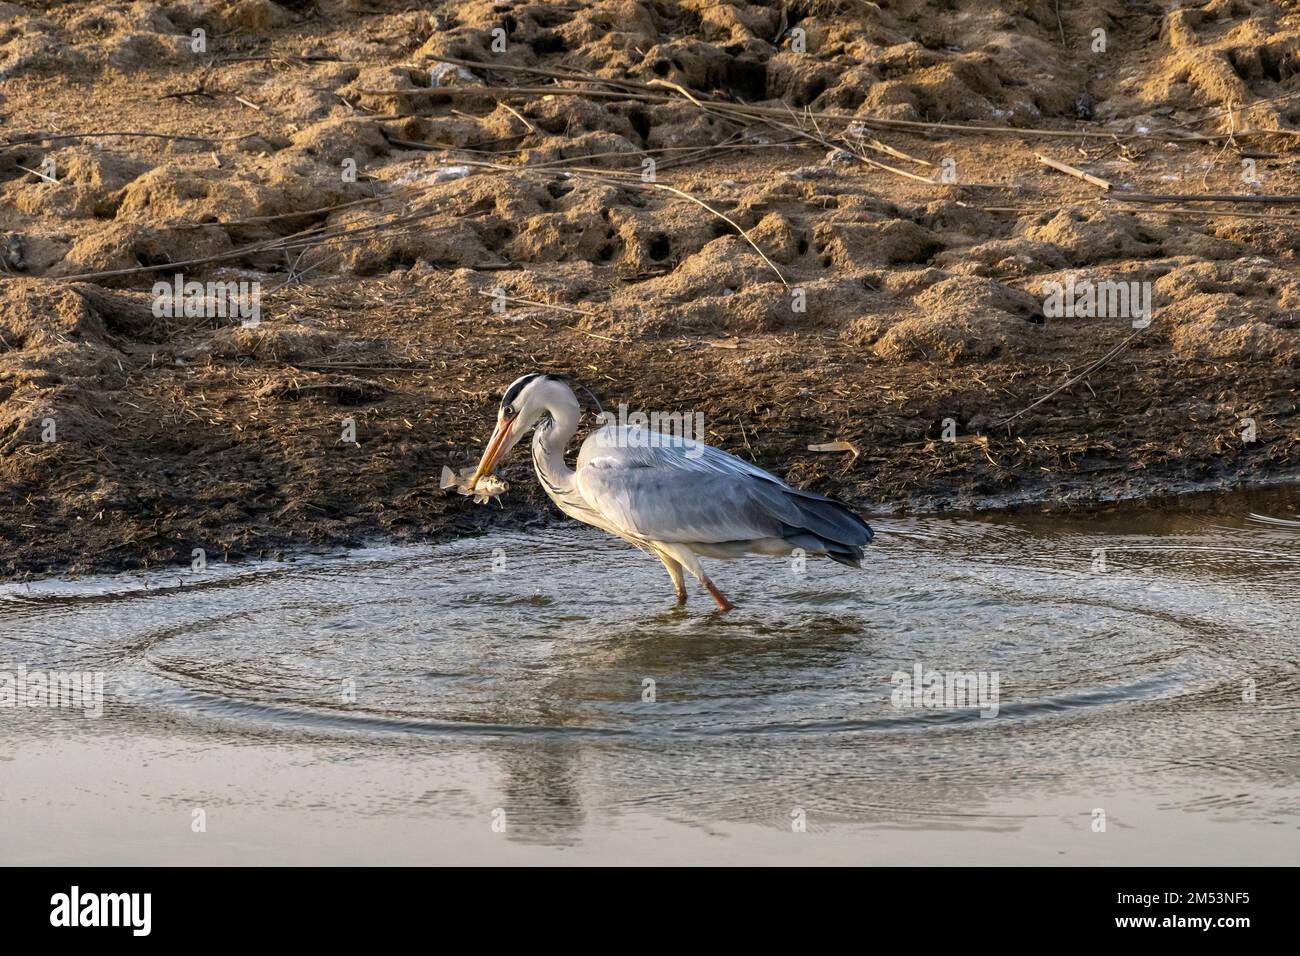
576 427 871 559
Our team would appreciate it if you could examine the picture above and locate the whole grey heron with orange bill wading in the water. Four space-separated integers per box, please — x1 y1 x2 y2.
471 373 872 610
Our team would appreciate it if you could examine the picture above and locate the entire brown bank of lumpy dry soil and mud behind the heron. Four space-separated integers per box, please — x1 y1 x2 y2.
0 0 1300 576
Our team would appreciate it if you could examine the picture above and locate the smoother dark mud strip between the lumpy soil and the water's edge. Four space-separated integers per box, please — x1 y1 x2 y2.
0 270 1297 575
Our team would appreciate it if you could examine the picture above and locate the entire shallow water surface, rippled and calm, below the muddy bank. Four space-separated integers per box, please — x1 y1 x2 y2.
0 490 1300 862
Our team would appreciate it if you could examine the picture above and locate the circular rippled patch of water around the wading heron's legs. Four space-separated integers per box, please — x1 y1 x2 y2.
3 520 1300 739
